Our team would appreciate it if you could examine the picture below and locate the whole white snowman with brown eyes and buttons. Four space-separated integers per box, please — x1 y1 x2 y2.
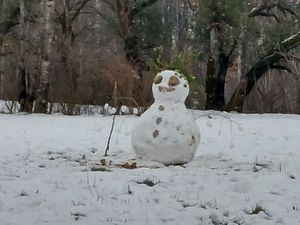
131 70 200 165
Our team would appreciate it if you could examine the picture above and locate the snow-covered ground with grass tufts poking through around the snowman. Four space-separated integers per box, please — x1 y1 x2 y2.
0 111 300 225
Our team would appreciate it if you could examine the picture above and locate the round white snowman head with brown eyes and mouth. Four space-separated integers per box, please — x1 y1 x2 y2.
152 70 190 103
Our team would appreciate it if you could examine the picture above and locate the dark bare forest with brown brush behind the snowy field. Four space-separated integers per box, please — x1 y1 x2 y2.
0 0 300 113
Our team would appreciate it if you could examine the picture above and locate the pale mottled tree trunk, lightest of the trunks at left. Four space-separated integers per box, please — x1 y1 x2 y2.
34 0 55 113
